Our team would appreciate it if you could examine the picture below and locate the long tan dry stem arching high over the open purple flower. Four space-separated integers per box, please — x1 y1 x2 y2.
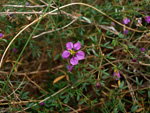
0 3 147 68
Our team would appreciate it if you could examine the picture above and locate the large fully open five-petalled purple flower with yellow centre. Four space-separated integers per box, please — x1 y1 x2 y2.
62 42 85 65
